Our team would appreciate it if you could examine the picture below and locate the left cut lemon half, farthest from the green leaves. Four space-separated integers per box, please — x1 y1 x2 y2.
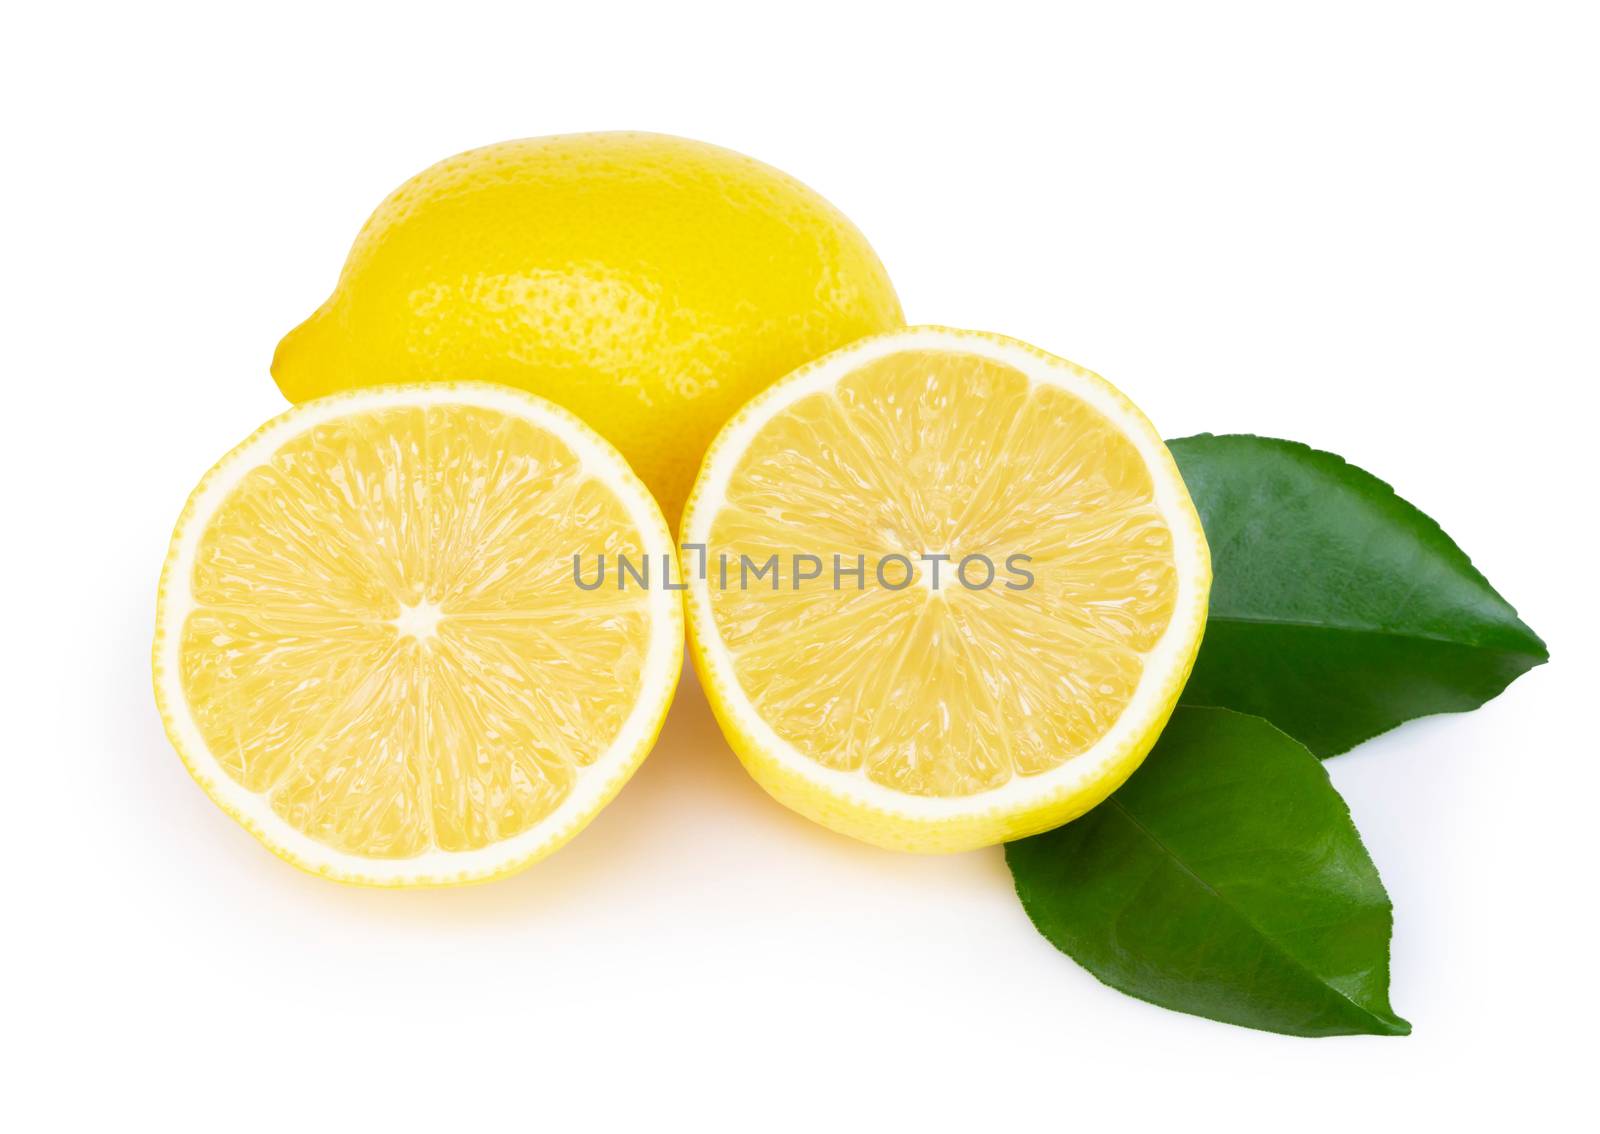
154 384 683 886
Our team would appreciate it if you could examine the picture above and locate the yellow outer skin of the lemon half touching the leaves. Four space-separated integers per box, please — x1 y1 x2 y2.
680 326 1211 854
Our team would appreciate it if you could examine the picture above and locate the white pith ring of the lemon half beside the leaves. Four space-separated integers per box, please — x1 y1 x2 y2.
682 328 1210 822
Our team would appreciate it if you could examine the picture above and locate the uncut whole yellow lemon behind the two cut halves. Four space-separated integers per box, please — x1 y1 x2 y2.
272 133 904 521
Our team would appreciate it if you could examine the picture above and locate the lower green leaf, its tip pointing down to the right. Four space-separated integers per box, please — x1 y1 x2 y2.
1006 709 1411 1035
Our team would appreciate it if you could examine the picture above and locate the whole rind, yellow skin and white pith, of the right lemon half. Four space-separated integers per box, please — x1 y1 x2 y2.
680 326 1211 852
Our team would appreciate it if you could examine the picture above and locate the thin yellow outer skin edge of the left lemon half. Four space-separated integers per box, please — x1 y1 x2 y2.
150 382 683 889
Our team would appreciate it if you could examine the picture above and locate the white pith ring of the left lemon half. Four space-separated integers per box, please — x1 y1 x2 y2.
154 382 683 886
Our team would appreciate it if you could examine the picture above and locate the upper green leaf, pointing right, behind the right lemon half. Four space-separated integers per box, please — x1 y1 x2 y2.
1168 433 1549 757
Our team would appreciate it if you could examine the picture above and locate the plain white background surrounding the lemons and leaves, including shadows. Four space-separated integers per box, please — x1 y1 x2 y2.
0 0 1600 1131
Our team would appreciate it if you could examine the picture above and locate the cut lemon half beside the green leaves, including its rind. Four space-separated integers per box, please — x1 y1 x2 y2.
680 328 1211 851
